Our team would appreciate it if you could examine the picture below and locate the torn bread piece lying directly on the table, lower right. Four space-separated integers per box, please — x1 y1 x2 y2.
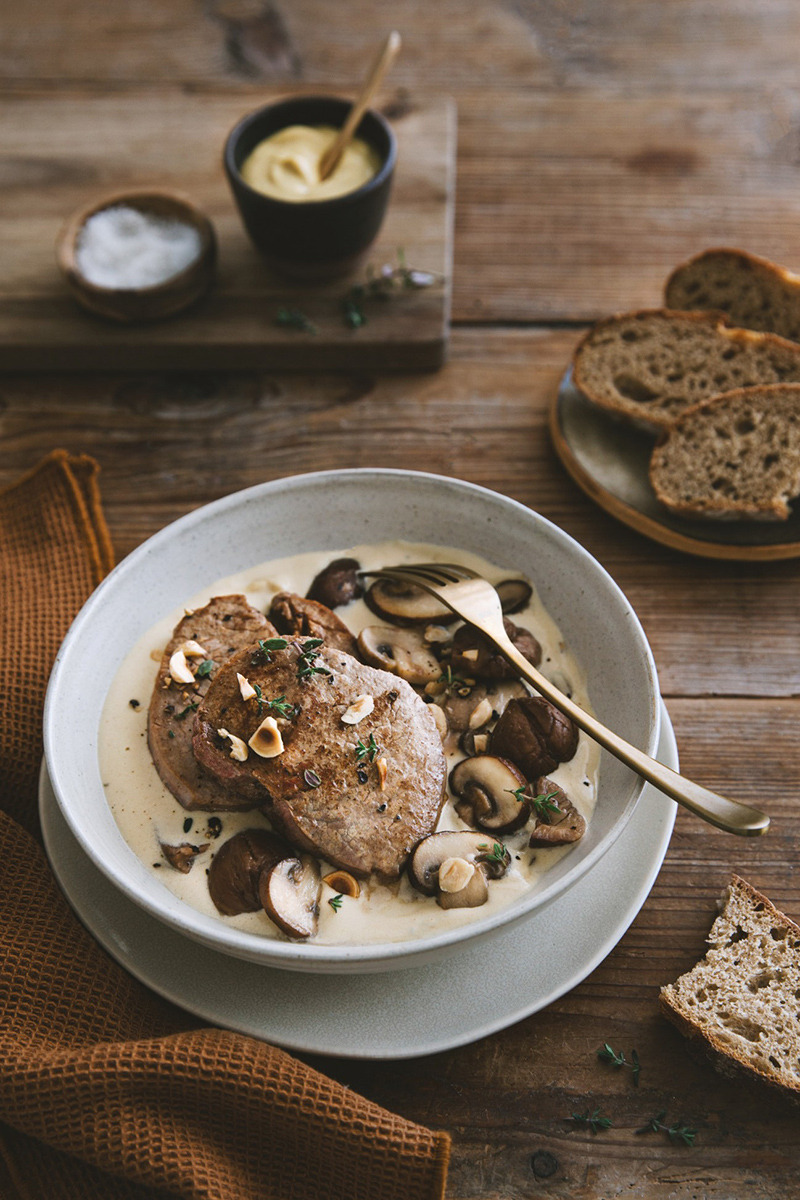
661 875 800 1099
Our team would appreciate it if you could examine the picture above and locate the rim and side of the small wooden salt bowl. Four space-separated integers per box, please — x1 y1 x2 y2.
55 187 217 300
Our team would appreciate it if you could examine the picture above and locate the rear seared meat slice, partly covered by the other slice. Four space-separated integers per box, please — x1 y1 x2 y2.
148 595 275 812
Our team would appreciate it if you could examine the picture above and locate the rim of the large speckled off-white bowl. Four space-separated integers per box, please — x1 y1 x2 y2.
43 467 661 971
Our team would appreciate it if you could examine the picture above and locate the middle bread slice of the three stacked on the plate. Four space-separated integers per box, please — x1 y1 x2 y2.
573 308 800 431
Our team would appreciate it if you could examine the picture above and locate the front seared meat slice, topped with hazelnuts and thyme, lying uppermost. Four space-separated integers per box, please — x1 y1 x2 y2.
193 638 446 878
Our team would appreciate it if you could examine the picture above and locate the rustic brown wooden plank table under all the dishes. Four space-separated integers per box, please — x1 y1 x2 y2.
0 0 800 1200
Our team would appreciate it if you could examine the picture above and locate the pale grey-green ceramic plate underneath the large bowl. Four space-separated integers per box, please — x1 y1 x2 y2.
40 708 678 1058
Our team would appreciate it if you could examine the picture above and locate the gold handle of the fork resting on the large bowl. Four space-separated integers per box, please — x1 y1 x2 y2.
494 631 770 838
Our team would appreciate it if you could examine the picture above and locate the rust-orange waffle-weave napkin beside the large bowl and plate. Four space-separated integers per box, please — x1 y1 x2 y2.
0 451 450 1200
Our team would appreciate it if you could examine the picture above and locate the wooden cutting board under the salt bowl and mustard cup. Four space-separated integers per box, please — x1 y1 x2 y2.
0 89 456 371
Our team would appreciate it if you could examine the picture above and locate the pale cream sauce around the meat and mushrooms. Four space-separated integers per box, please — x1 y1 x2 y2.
100 541 600 944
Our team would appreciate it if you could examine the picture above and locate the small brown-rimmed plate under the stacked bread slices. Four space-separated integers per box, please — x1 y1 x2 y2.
549 368 800 562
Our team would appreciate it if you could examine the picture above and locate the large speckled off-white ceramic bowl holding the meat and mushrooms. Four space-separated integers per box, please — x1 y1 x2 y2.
44 469 660 972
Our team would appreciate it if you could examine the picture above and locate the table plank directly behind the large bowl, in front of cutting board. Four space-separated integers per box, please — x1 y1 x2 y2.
0 330 800 696
